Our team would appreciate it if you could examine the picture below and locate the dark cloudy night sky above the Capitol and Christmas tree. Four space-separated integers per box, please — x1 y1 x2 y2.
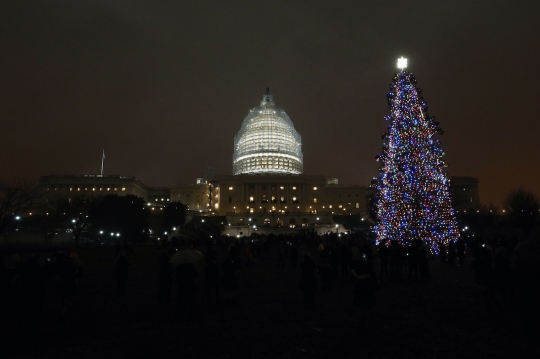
0 0 540 204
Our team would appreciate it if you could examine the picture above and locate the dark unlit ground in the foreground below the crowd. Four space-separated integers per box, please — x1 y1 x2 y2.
3 242 534 358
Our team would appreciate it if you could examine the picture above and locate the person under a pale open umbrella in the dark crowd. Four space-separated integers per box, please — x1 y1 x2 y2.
170 249 203 323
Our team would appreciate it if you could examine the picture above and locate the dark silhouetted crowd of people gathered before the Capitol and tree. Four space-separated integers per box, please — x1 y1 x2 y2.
0 234 540 354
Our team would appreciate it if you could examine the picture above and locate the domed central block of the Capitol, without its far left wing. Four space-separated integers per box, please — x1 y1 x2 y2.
170 89 368 235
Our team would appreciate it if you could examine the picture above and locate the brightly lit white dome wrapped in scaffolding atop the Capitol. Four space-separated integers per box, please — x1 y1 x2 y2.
233 89 303 175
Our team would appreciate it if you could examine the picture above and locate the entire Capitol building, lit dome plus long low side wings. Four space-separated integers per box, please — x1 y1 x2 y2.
40 89 478 236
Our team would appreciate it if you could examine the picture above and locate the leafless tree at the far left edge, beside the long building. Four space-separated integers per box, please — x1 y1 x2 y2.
0 179 44 240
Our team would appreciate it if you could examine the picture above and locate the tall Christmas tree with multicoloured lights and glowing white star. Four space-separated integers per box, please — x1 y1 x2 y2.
372 58 459 251
